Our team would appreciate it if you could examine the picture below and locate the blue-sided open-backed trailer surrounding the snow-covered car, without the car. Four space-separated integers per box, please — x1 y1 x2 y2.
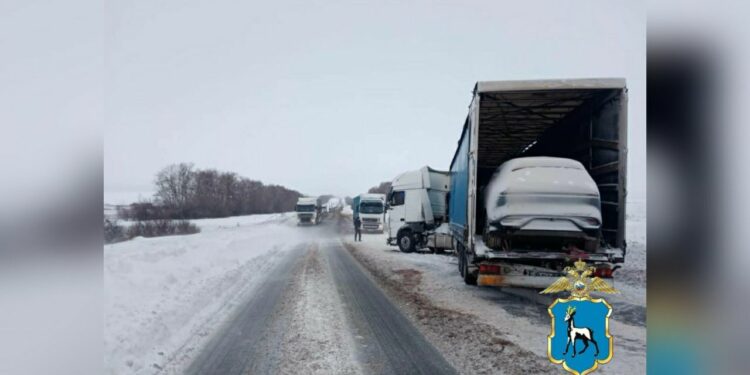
449 79 627 285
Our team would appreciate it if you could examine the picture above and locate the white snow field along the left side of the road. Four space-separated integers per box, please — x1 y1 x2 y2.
104 213 309 374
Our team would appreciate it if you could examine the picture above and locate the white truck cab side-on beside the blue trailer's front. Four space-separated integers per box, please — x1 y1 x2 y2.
386 166 452 252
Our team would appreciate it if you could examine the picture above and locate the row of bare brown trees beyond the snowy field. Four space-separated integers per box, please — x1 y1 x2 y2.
119 163 301 220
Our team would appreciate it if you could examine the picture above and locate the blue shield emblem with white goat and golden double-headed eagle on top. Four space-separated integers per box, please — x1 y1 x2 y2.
541 259 619 375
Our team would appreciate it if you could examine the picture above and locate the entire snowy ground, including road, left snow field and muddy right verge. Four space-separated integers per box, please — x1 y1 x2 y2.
104 205 646 374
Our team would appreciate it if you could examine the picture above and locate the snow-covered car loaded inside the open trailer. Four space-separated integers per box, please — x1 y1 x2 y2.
484 157 602 252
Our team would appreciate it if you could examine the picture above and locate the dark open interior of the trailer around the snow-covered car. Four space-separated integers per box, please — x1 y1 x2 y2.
475 79 627 249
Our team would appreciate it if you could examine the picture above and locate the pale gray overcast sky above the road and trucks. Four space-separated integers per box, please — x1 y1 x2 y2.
104 0 646 203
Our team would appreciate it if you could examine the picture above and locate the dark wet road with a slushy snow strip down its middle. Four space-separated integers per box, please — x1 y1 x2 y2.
187 241 455 375
